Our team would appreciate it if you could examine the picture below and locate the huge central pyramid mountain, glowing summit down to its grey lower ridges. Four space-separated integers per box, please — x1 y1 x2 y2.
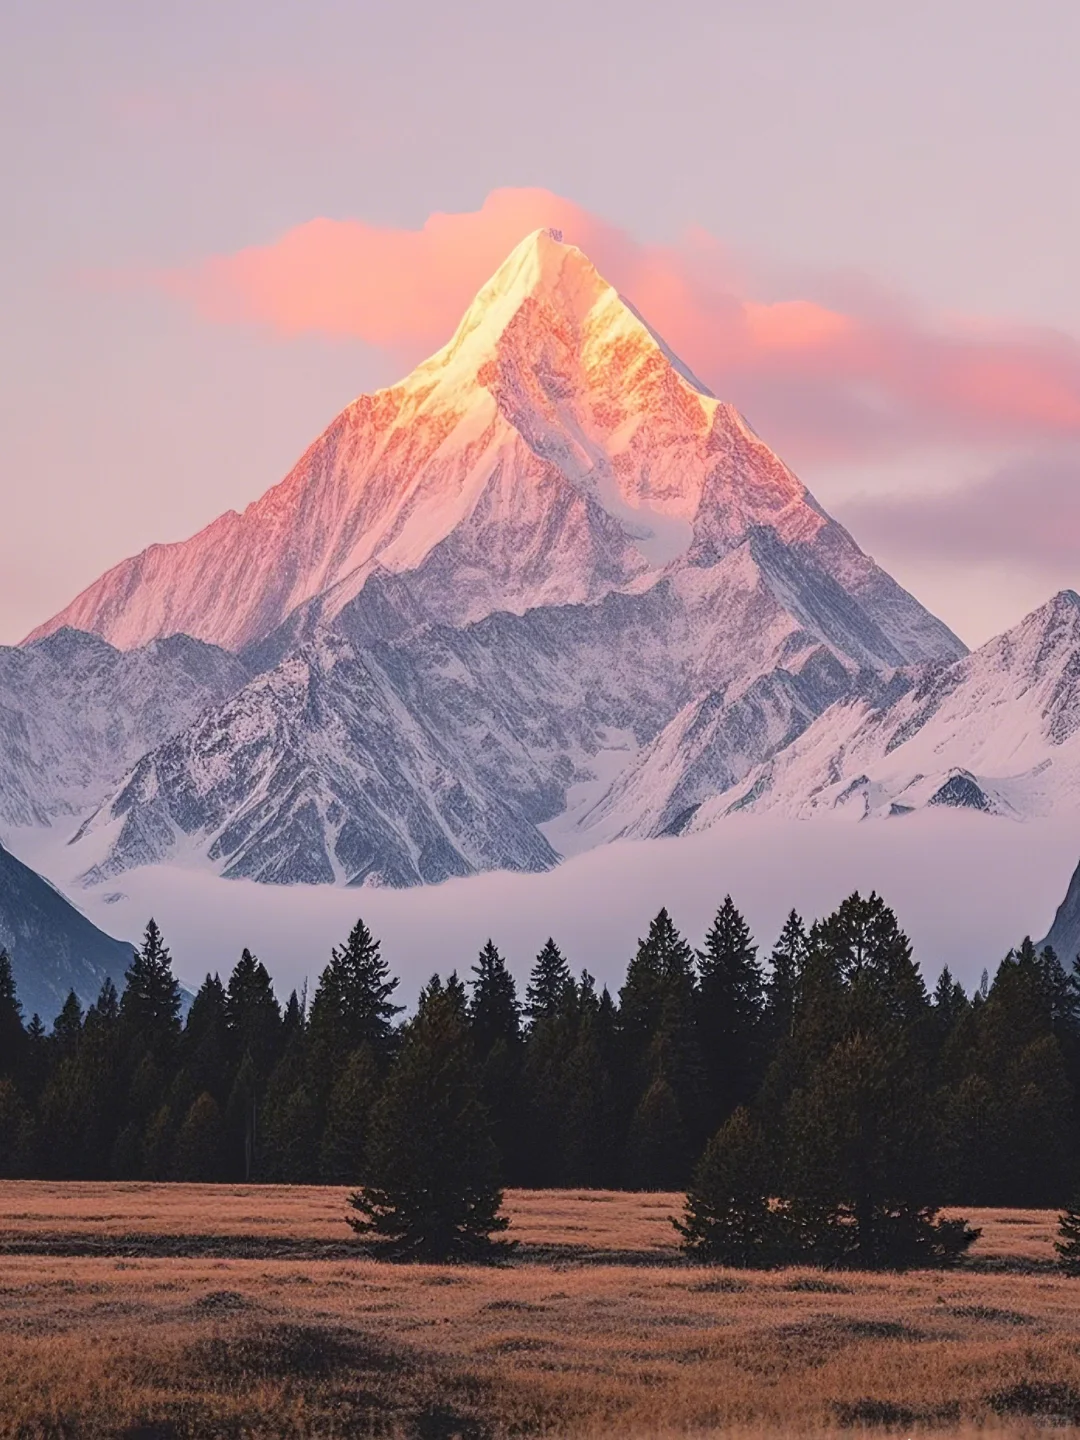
19 230 965 886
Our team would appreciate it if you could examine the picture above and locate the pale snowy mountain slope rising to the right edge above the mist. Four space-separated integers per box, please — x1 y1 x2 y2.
690 590 1080 829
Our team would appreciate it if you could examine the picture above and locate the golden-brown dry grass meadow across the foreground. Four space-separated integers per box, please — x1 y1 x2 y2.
0 1182 1080 1440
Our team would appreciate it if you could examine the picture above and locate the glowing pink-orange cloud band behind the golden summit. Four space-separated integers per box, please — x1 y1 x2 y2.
156 189 1080 461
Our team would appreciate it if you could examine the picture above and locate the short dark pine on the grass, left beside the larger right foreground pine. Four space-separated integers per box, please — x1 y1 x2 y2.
672 1107 783 1266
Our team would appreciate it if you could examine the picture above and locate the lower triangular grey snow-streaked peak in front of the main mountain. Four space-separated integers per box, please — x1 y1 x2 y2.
75 635 556 886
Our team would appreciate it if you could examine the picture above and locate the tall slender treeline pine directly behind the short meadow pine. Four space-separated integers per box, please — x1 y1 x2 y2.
696 896 765 1129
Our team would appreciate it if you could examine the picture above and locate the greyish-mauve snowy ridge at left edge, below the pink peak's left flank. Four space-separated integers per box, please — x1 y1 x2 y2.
0 629 248 825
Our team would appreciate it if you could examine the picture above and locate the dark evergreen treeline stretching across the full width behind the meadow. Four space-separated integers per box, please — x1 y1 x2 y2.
0 894 1080 1221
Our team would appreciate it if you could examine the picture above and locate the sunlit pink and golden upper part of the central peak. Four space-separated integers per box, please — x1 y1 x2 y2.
30 230 962 661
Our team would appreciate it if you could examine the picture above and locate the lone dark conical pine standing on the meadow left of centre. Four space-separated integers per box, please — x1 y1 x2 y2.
350 986 508 1260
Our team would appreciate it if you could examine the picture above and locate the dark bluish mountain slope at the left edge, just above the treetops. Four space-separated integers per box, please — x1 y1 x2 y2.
0 845 131 1025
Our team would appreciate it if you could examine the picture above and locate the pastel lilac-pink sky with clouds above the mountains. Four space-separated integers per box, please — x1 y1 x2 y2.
0 0 1080 644
